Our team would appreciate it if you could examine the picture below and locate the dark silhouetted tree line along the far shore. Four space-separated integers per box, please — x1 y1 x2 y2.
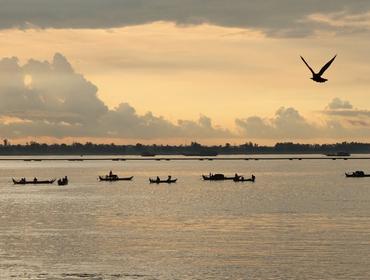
0 140 370 156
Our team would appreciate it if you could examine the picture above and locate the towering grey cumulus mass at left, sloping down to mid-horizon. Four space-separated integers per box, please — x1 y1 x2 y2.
0 54 234 139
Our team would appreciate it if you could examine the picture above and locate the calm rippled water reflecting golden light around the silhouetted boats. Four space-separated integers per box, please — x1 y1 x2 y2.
0 156 370 280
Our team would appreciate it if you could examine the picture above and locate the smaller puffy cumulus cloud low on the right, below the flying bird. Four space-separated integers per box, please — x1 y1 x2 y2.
236 98 370 141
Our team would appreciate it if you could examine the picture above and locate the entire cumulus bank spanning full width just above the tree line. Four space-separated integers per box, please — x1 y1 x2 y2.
0 54 370 141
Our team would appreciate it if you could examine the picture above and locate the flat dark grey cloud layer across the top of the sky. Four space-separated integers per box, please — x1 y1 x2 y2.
0 0 370 37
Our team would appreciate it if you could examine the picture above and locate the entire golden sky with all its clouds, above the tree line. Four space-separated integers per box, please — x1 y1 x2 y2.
0 0 370 144
